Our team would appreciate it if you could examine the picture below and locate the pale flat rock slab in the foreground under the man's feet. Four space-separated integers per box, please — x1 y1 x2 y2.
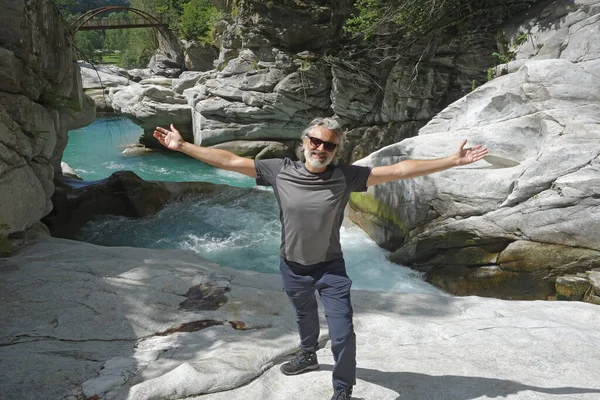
0 237 600 400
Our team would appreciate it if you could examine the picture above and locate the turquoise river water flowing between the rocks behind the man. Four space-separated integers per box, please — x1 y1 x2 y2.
63 117 440 293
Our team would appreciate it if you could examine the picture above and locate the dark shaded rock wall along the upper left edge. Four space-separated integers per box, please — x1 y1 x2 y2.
0 0 95 237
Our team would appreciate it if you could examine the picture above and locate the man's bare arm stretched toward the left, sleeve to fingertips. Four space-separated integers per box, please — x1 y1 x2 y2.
154 124 256 178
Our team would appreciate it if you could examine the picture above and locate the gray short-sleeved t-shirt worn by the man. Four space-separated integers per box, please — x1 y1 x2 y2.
254 158 371 265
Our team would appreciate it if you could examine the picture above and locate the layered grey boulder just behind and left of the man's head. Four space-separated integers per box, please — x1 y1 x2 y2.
185 50 331 145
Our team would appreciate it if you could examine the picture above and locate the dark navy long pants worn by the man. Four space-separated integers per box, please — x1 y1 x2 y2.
279 259 356 389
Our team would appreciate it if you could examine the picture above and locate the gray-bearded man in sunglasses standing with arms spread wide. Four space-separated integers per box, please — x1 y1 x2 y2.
154 118 487 400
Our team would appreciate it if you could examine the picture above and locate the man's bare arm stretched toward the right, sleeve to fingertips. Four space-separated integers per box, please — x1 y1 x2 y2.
367 139 487 186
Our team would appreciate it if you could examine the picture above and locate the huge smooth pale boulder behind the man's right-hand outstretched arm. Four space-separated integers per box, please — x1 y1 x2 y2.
353 56 600 298
